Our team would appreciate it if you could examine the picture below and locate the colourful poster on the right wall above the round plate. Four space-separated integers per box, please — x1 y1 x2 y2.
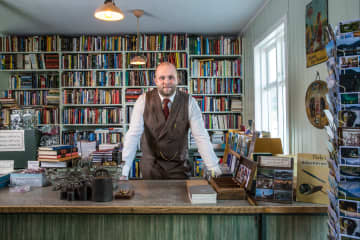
305 0 328 67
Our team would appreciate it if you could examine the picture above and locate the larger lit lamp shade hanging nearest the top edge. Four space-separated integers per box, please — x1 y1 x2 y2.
94 0 124 21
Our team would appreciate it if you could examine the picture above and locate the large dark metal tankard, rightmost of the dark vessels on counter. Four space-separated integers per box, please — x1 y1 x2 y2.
92 169 113 202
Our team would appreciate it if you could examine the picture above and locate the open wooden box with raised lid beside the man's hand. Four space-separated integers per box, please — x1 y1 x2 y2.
209 154 256 200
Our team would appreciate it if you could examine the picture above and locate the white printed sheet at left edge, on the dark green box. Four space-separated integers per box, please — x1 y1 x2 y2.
0 130 25 152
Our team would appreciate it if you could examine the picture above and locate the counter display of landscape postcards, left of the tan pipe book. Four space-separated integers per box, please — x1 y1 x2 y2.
255 156 293 203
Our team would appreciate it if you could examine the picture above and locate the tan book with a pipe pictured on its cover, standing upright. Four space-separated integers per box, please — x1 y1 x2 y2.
296 153 330 204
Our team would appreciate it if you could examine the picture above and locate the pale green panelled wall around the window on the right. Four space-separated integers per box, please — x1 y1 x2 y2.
243 0 360 153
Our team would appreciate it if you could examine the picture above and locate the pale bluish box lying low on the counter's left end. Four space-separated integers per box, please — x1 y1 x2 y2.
10 173 47 187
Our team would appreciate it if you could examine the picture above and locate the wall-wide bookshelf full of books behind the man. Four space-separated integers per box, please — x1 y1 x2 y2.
0 34 243 160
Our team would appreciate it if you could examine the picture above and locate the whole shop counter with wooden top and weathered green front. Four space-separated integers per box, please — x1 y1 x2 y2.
0 180 327 240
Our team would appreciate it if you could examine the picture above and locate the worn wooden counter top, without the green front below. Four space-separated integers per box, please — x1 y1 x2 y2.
0 180 327 214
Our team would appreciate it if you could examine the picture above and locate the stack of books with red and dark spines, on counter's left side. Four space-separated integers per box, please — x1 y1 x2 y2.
38 145 79 167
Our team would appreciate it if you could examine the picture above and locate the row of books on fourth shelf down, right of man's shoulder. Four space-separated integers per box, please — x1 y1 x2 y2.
194 96 241 112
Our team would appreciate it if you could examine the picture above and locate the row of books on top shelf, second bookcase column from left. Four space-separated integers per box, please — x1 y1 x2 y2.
61 35 123 51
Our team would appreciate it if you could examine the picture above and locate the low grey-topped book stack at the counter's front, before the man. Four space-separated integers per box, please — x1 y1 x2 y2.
186 180 217 204
